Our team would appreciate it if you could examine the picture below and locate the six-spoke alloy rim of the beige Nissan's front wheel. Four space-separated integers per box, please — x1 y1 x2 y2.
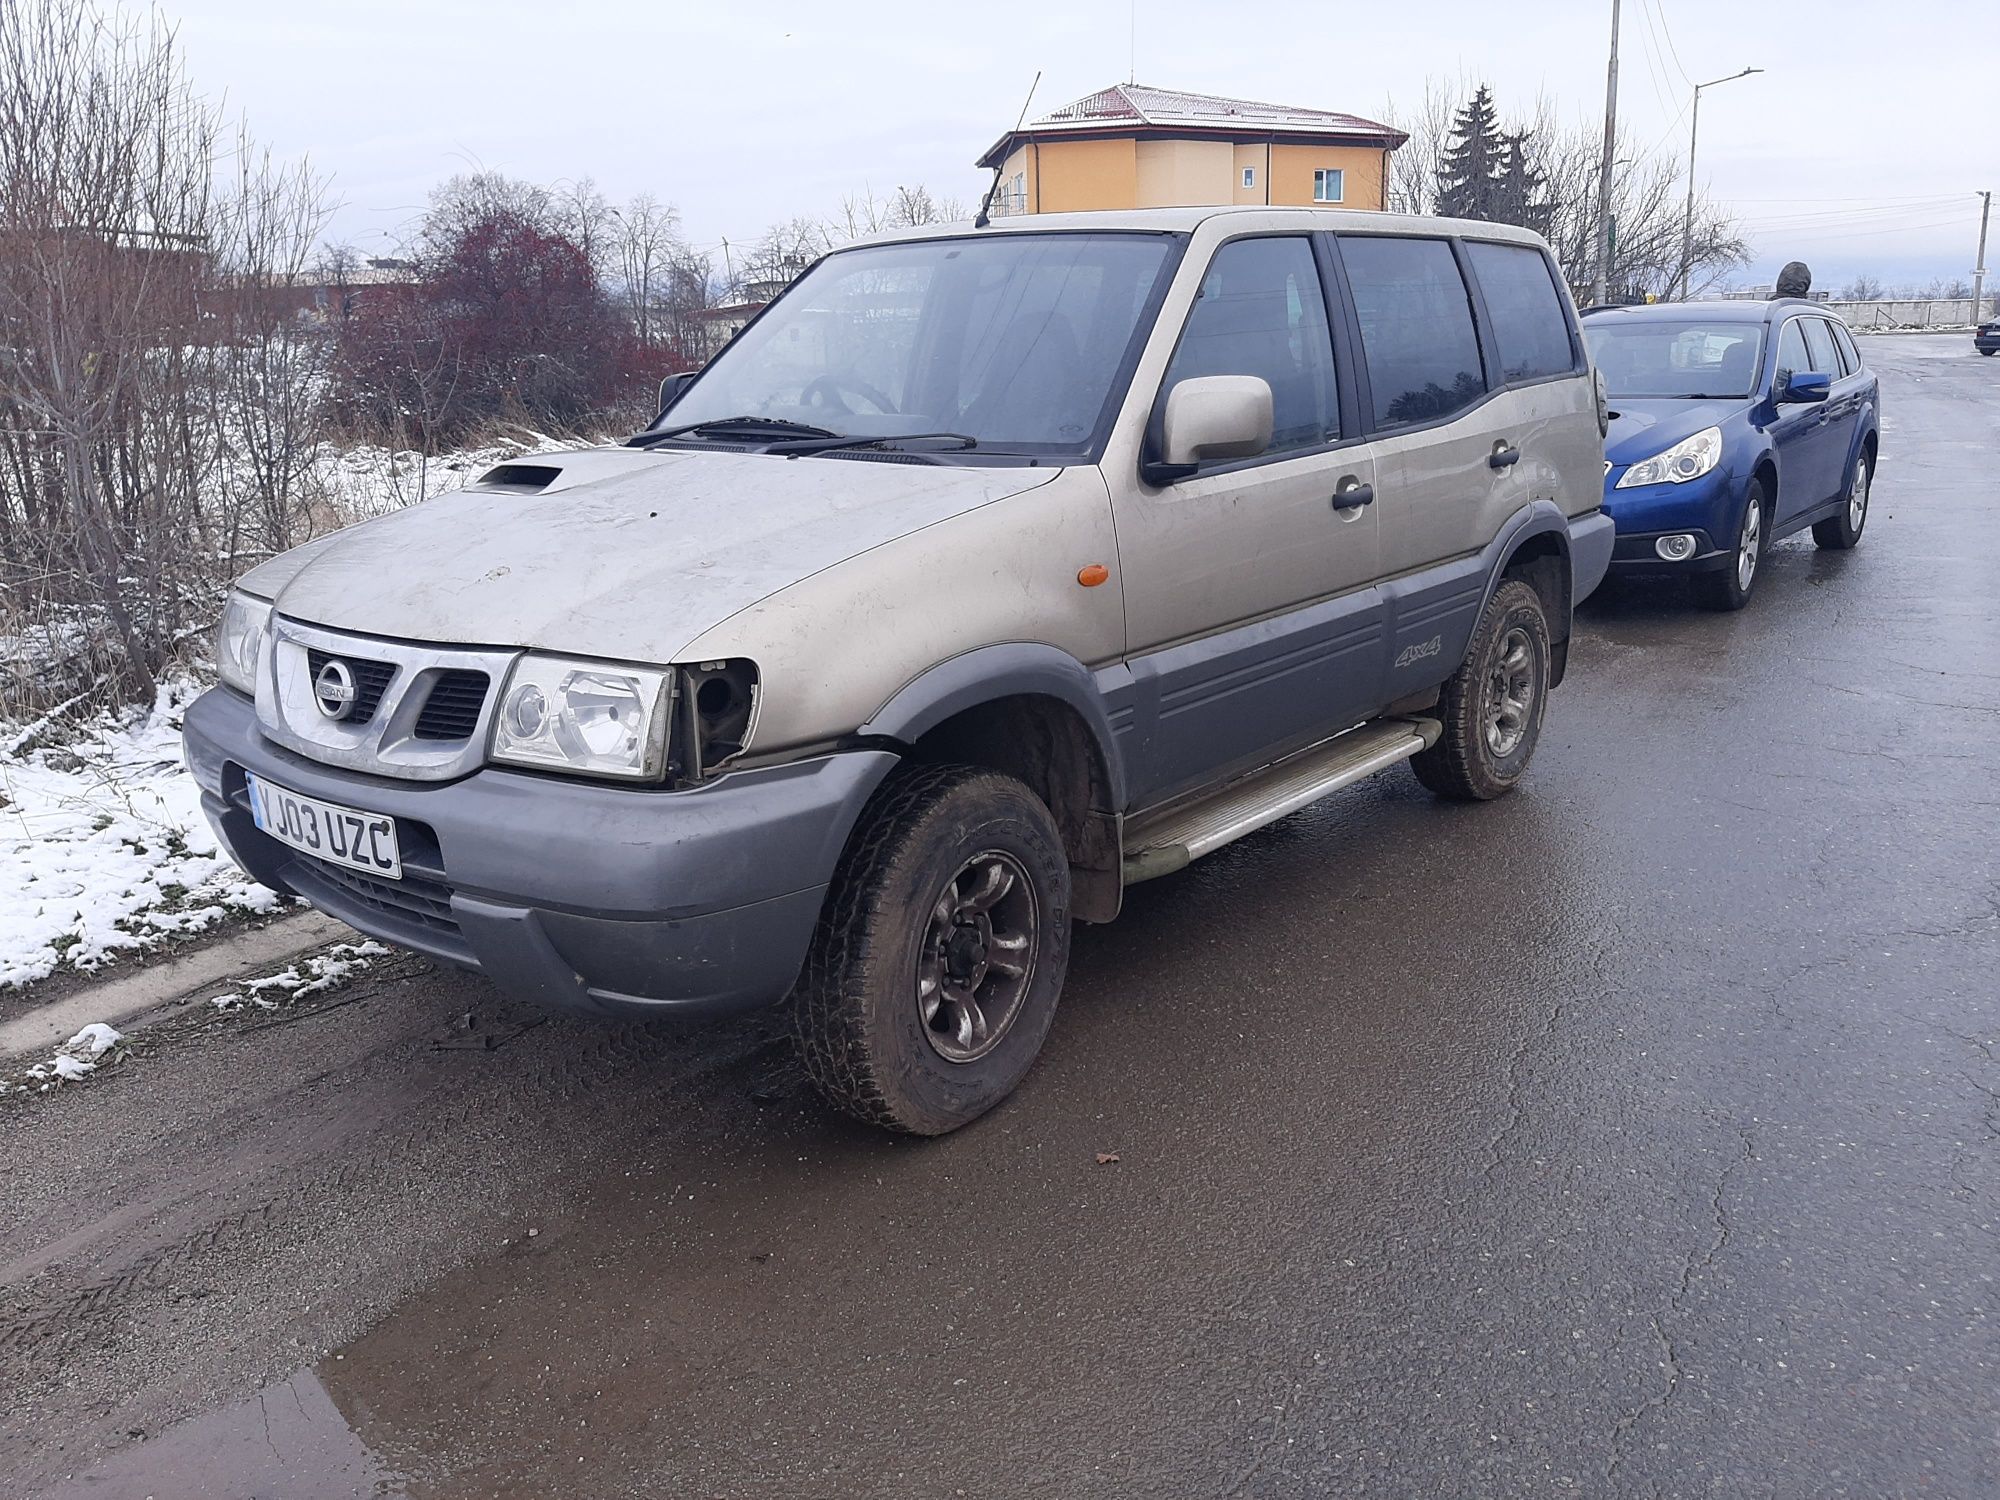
916 850 1042 1062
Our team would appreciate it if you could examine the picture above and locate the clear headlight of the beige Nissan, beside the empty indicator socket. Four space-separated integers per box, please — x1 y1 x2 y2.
494 656 668 780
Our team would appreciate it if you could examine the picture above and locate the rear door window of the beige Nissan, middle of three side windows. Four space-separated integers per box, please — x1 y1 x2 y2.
1340 234 1486 428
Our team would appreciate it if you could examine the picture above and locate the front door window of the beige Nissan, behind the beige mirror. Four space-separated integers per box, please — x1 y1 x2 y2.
1160 238 1340 454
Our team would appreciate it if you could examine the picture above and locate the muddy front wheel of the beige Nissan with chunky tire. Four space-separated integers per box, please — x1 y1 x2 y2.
792 766 1070 1136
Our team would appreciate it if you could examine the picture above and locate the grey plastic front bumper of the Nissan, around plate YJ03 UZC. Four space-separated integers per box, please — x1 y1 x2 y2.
184 688 896 1014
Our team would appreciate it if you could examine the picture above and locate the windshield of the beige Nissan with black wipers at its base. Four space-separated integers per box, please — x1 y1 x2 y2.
656 234 1174 454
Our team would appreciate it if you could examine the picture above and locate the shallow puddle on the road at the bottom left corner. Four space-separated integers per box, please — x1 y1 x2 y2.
36 1370 402 1500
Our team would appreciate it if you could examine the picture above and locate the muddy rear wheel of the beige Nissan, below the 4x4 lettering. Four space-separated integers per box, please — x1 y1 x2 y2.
1410 578 1552 802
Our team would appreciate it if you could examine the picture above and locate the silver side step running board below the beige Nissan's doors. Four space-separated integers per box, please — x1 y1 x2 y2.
1124 718 1444 886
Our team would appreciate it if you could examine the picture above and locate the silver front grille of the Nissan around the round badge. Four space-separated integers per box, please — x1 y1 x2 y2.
256 616 520 782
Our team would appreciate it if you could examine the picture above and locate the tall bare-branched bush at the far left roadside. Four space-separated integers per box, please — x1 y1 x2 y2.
0 0 324 718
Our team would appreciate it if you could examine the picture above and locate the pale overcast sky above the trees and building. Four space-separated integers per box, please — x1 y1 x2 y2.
176 0 2000 286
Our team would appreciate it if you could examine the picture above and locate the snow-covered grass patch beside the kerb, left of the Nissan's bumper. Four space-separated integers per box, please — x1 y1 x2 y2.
0 676 280 990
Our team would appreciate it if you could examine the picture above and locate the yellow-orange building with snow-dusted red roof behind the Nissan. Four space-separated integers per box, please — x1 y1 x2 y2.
980 84 1410 214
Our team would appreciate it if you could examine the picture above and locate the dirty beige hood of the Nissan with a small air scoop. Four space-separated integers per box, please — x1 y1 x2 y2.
242 448 1062 664
